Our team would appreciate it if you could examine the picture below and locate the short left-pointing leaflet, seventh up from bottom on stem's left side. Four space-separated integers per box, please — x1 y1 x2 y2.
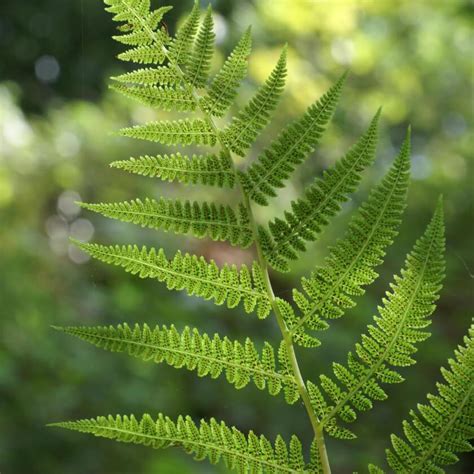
110 84 197 112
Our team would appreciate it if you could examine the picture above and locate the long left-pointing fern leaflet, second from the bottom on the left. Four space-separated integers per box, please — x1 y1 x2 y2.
56 324 298 403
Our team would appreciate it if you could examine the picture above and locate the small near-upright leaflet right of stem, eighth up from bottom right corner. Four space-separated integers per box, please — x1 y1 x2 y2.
186 4 215 87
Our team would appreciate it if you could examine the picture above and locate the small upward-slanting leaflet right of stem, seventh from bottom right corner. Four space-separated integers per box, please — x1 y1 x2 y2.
201 28 252 117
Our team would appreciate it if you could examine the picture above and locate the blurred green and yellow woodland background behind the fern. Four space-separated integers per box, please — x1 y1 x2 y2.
0 0 474 474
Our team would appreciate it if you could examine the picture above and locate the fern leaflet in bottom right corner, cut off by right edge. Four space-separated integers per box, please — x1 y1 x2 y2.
386 325 474 473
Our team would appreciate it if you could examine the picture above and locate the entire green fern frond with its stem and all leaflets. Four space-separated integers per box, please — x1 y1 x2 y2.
53 0 474 473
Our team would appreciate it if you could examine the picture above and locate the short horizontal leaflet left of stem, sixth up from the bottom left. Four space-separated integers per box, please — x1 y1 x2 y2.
120 119 217 145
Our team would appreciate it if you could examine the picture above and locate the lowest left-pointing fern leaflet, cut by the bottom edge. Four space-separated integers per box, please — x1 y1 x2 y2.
48 413 308 474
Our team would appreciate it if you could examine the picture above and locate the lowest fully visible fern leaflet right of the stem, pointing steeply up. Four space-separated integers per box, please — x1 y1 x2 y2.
312 200 444 437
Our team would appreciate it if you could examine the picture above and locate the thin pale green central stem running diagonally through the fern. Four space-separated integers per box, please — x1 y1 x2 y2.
120 2 331 474
